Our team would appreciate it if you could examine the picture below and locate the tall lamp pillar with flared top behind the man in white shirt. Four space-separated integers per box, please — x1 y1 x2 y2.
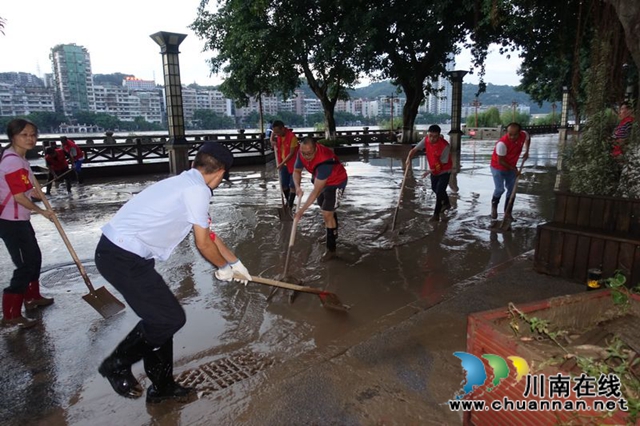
150 31 189 175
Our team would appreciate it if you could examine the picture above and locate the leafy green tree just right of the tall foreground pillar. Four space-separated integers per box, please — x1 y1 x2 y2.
193 0 368 138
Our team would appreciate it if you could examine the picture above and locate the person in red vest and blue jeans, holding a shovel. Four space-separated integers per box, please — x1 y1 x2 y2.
491 123 531 219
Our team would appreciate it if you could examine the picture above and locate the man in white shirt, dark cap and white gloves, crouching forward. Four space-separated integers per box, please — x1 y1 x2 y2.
95 142 251 403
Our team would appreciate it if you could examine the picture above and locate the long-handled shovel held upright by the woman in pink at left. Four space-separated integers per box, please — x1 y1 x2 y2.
33 175 125 318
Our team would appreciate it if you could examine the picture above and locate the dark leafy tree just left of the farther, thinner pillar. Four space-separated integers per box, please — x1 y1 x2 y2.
362 0 474 143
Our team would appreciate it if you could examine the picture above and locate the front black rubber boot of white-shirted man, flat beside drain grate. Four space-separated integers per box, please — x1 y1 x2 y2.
144 339 195 404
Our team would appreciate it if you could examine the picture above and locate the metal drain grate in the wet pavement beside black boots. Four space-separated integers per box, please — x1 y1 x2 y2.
176 352 274 392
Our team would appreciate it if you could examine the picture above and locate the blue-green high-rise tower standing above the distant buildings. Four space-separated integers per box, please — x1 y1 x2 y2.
50 44 95 116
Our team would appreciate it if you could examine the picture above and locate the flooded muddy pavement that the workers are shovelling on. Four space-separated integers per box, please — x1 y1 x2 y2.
0 135 568 425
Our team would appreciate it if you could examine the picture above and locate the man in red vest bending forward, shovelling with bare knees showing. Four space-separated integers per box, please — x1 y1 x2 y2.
292 138 347 260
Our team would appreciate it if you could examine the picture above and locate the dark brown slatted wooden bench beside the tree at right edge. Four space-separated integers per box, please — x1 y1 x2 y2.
534 192 640 286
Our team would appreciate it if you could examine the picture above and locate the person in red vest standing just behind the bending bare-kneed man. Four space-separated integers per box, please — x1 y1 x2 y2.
272 120 298 208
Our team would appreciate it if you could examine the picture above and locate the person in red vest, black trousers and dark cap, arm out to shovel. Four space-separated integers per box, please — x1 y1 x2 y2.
407 124 453 222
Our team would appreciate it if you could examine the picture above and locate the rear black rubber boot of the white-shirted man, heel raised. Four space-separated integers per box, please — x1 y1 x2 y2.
98 322 153 398
